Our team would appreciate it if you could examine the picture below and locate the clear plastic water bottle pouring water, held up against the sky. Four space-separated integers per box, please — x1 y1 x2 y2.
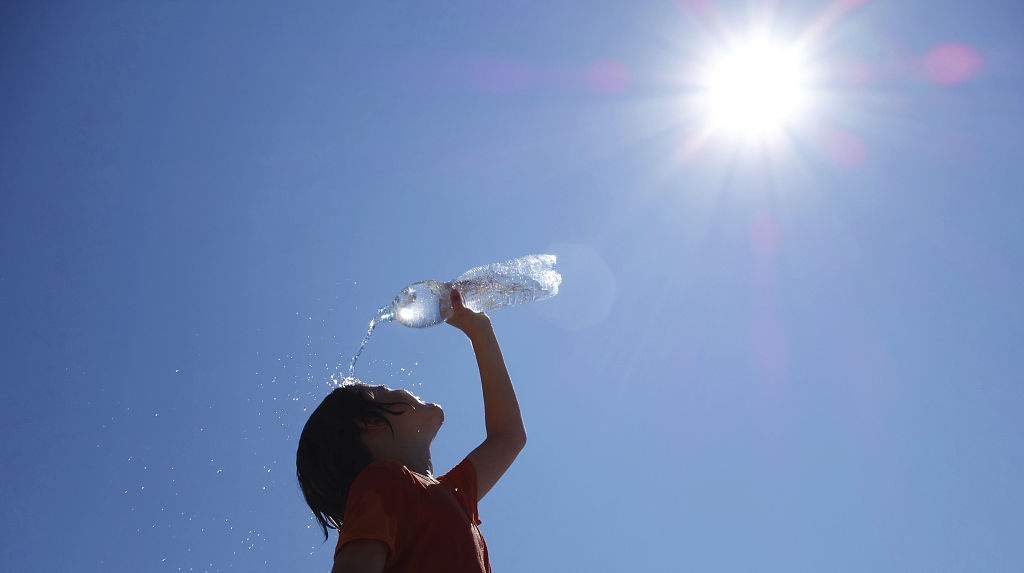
377 255 562 328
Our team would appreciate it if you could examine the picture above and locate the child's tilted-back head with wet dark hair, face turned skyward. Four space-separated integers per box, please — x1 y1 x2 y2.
295 383 444 537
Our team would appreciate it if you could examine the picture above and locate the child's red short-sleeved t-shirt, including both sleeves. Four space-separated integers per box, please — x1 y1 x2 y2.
334 459 490 573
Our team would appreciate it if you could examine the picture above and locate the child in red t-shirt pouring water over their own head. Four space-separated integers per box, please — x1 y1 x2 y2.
296 289 526 573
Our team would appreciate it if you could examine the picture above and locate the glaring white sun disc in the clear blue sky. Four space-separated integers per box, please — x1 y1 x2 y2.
700 41 809 138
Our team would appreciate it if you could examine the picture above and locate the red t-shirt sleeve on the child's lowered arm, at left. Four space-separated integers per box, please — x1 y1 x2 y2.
335 462 408 556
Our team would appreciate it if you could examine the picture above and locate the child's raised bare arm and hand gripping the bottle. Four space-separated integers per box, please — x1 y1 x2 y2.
447 289 526 499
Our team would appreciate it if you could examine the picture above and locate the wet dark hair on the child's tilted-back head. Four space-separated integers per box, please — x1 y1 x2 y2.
295 384 402 541
